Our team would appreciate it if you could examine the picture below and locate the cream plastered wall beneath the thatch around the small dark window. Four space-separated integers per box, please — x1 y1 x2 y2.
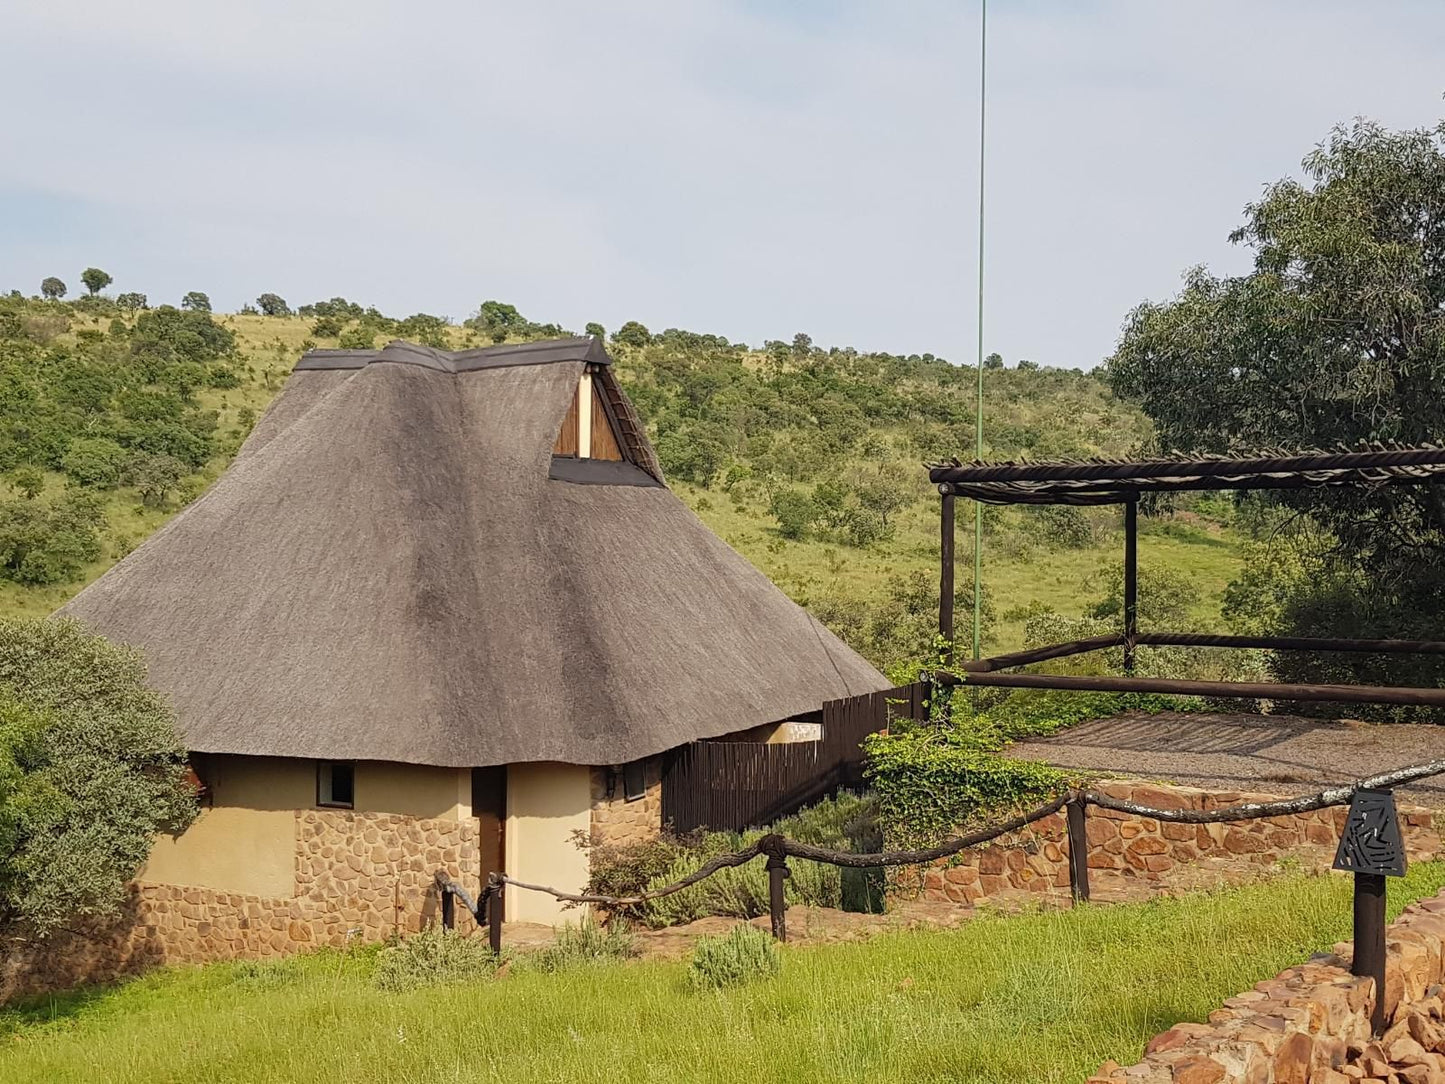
137 754 471 898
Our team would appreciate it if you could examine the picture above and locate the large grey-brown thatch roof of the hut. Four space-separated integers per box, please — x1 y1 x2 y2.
64 338 889 766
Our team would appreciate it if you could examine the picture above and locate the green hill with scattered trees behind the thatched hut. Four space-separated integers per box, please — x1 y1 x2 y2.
0 280 1235 666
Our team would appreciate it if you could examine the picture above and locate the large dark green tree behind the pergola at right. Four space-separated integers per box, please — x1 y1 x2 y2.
1108 121 1445 717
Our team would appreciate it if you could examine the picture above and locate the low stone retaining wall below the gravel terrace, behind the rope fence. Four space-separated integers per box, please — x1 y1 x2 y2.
896 780 1441 903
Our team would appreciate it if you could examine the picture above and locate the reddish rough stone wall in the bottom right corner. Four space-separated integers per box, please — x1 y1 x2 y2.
1090 892 1445 1084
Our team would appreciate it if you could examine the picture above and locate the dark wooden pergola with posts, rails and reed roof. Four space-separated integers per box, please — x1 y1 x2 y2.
929 445 1445 707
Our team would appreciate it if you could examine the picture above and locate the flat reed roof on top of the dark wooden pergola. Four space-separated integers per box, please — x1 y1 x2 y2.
928 444 1445 504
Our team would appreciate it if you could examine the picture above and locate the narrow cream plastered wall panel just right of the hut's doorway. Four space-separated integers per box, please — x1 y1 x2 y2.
506 763 592 924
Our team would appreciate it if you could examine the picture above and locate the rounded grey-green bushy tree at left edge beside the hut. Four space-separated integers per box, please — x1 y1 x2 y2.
0 619 197 938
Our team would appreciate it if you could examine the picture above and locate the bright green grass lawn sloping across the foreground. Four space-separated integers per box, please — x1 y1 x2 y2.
0 863 1445 1084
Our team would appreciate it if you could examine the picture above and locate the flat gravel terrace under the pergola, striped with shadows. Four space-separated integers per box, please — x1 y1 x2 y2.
1009 713 1445 808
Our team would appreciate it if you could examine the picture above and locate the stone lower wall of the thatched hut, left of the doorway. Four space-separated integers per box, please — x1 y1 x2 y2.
0 809 481 1002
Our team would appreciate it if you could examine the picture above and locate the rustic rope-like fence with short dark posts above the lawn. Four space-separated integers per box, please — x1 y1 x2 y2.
435 759 1445 977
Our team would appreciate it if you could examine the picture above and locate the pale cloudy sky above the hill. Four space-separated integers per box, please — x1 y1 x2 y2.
0 0 1445 369
